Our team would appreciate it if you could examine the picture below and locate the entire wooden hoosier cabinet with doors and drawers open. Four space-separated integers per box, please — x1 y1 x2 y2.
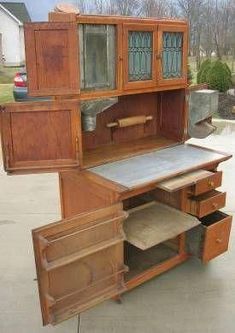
1 9 231 325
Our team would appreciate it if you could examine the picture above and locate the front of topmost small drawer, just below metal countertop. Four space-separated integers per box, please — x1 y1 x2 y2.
192 171 222 195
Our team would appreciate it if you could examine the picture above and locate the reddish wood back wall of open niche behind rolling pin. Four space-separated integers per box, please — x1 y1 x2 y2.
83 89 185 150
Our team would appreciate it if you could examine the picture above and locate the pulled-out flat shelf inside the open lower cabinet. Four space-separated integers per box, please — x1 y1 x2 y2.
124 201 200 250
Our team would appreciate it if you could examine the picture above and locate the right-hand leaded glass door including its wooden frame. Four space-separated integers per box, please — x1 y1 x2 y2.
157 25 187 85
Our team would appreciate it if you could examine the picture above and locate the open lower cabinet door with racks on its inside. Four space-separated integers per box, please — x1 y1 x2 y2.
32 204 127 325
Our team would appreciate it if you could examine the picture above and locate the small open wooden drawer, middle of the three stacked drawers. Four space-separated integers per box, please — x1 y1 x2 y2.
186 190 226 217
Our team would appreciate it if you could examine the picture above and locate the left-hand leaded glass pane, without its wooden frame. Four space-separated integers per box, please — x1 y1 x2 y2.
128 31 153 81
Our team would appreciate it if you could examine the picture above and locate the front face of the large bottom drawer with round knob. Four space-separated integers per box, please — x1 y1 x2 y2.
201 212 232 263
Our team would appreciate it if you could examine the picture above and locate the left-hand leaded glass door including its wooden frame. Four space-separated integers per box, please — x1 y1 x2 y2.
123 24 157 89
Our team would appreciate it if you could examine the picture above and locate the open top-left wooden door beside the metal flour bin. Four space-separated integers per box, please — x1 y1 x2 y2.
24 22 79 96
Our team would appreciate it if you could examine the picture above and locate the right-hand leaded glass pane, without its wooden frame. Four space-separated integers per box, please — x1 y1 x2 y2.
162 32 183 79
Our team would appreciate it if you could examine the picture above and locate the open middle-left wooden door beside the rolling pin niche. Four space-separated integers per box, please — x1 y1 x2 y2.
1 100 81 173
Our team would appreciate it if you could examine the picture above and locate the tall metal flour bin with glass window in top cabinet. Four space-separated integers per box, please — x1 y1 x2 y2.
79 24 117 92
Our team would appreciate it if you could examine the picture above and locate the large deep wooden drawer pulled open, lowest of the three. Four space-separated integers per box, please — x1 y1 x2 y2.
187 211 232 263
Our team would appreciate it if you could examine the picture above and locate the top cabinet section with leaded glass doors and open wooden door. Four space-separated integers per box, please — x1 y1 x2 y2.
25 14 188 100
